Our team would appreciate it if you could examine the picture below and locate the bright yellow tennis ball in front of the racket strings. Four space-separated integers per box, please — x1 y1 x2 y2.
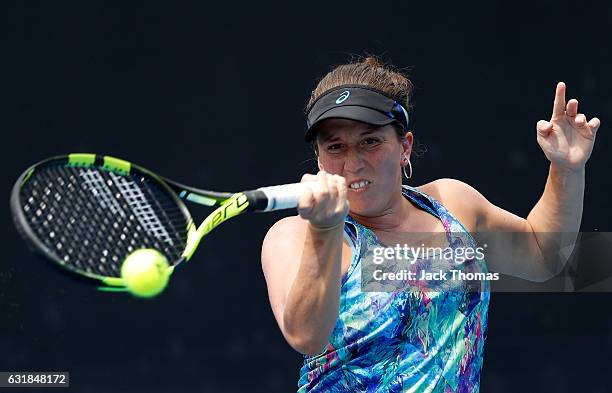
121 248 171 297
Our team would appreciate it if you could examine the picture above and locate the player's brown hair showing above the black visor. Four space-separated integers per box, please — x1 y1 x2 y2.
306 56 413 152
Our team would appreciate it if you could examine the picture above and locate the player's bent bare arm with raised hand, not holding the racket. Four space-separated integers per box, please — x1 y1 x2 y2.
442 82 600 281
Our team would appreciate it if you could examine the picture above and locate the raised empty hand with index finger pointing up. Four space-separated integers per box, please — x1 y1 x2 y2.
536 82 601 170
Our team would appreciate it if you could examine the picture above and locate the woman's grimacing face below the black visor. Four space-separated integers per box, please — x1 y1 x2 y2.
317 119 412 216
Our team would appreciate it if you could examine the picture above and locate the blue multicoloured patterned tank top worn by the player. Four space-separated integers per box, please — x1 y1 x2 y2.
298 186 490 393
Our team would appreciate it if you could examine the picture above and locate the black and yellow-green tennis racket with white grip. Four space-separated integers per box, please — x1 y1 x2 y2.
11 153 306 291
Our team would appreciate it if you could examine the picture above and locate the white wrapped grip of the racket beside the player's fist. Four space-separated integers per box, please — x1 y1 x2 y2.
244 183 308 212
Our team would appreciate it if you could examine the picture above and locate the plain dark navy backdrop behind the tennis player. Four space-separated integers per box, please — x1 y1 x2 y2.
0 0 612 393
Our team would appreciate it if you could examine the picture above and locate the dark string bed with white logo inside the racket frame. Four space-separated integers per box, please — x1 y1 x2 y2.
20 165 188 277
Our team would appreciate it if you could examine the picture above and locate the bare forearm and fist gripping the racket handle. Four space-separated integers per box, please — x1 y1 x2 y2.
262 172 348 355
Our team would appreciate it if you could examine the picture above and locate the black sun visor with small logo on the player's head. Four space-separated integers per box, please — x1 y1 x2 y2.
304 85 408 142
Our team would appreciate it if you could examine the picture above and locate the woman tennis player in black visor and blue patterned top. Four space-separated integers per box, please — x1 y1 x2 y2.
262 58 600 393
